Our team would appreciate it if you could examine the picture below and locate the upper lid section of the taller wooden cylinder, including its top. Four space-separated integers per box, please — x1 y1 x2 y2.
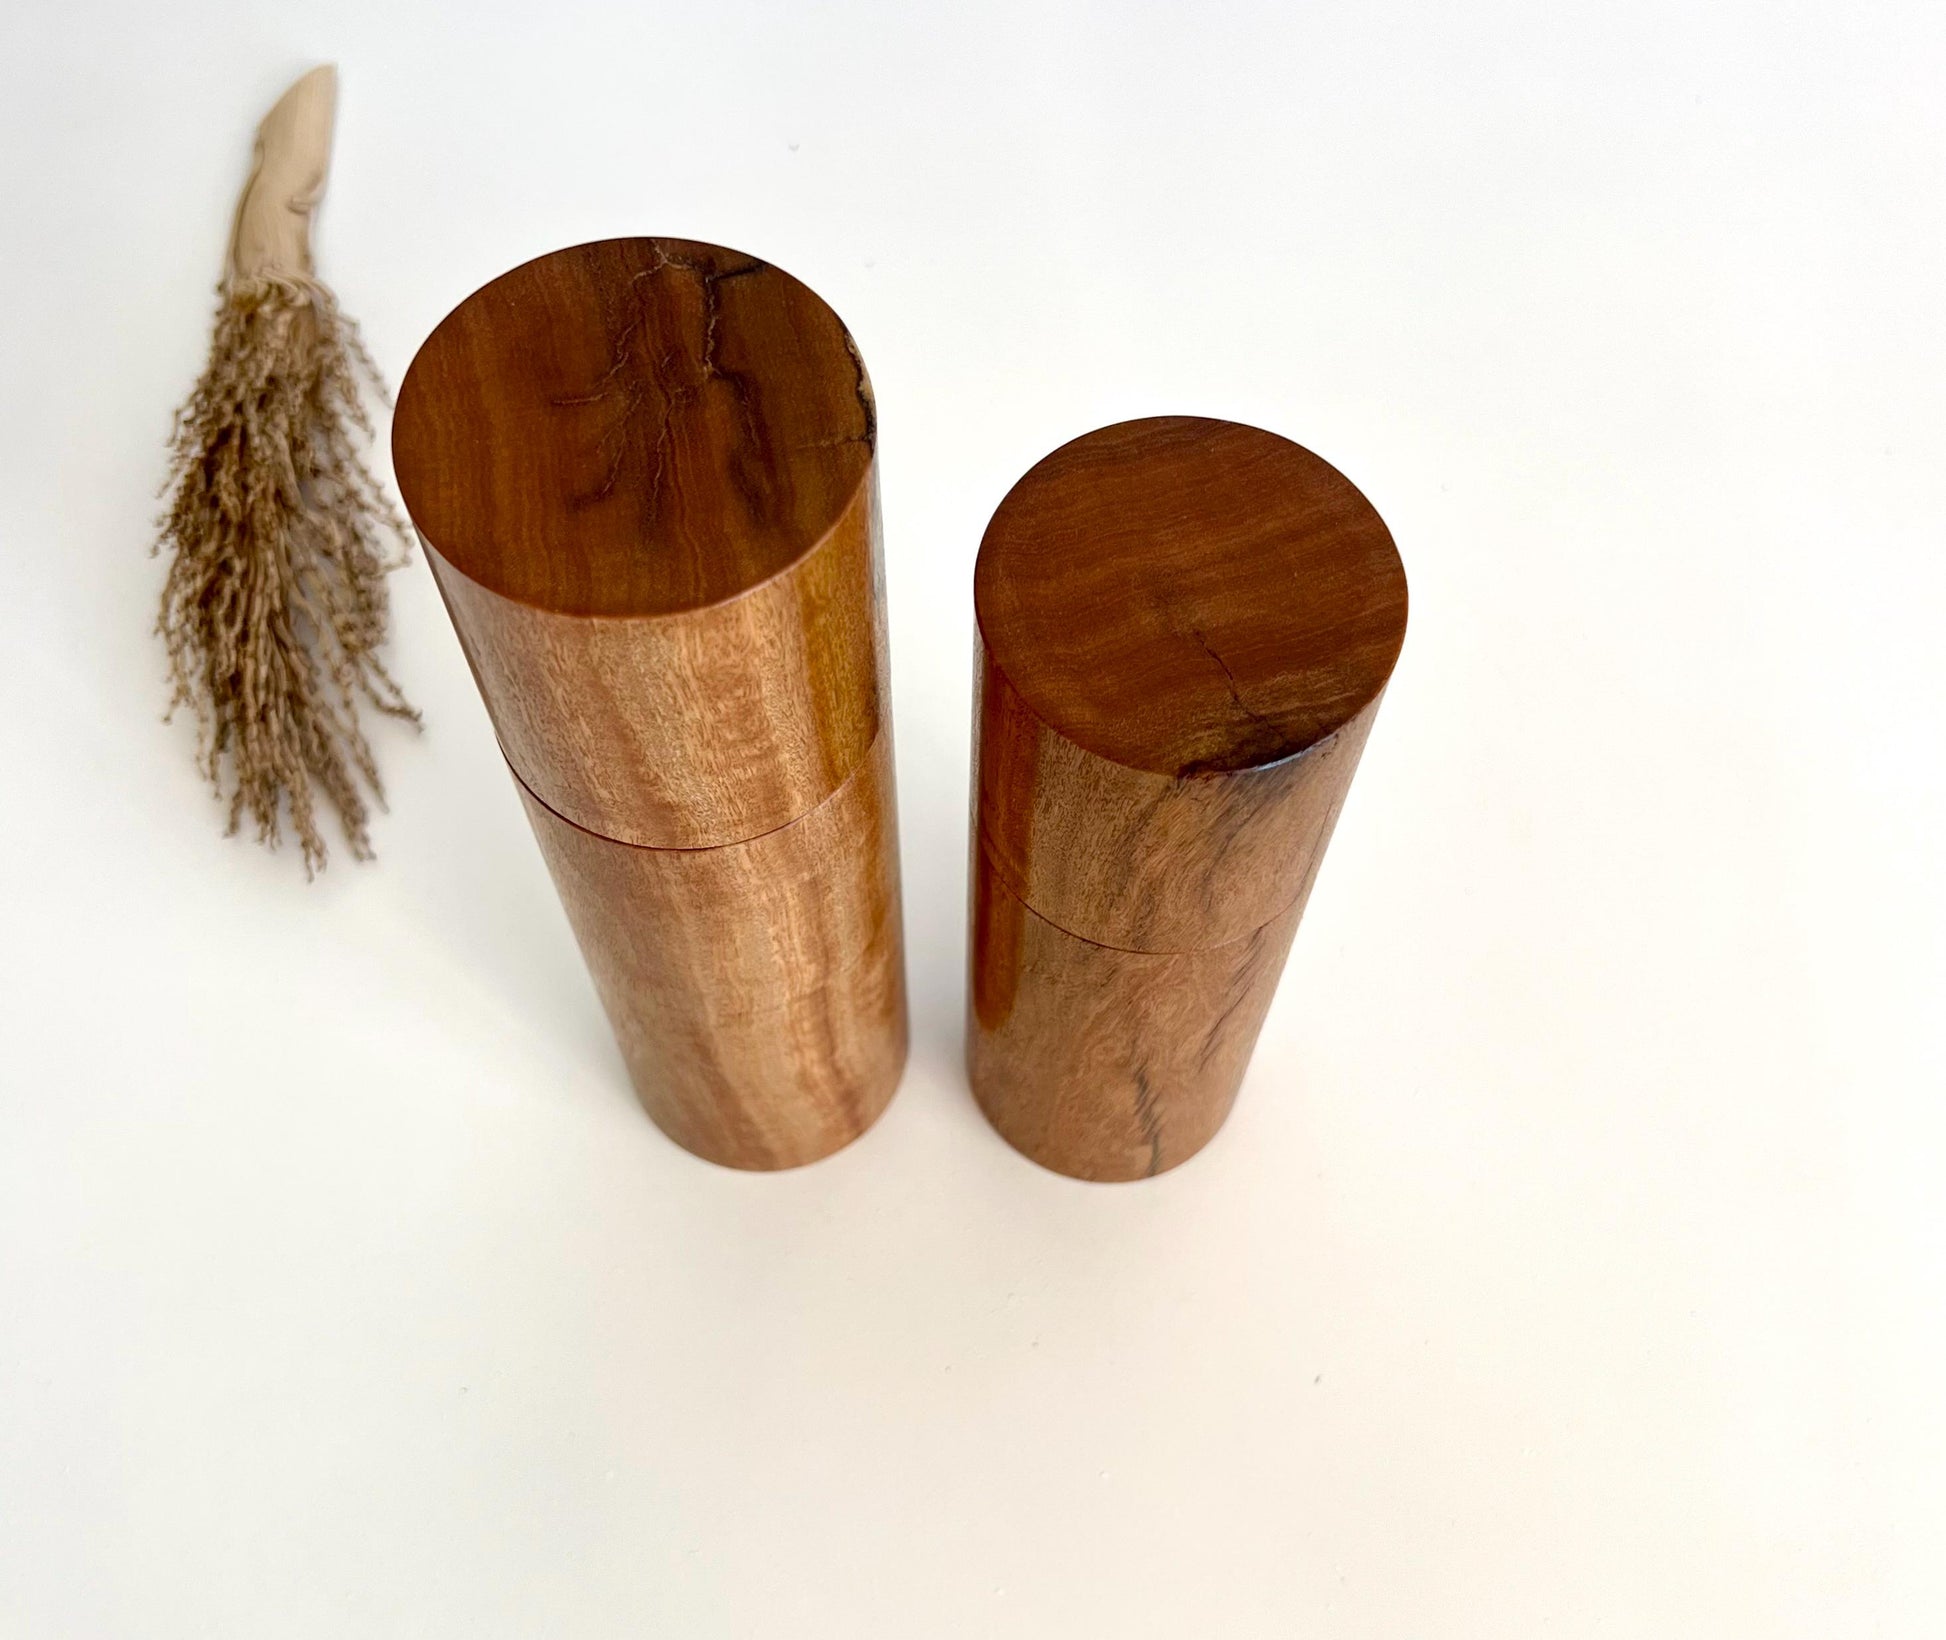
393 239 889 848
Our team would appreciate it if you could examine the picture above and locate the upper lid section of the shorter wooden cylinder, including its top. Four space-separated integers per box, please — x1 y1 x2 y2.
973 416 1407 949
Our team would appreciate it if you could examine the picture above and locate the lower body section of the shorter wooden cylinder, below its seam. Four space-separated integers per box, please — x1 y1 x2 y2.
967 844 1304 1181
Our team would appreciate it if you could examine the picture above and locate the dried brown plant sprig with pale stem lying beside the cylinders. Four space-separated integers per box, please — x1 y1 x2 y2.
156 68 418 875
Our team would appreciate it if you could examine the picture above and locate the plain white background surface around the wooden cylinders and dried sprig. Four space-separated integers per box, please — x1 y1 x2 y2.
0 0 1946 1640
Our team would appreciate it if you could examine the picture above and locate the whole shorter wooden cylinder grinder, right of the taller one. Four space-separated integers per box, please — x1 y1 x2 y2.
967 416 1407 1179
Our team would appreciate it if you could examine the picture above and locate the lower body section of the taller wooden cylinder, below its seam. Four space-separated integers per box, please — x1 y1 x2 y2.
516 735 907 1169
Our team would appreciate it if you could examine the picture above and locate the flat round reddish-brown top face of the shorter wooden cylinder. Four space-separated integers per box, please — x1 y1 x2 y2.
973 416 1405 776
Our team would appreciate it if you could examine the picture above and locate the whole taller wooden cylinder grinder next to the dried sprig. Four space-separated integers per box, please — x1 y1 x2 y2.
393 239 907 1167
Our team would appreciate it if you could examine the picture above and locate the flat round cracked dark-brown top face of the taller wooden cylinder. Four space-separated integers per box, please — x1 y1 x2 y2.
391 239 878 615
